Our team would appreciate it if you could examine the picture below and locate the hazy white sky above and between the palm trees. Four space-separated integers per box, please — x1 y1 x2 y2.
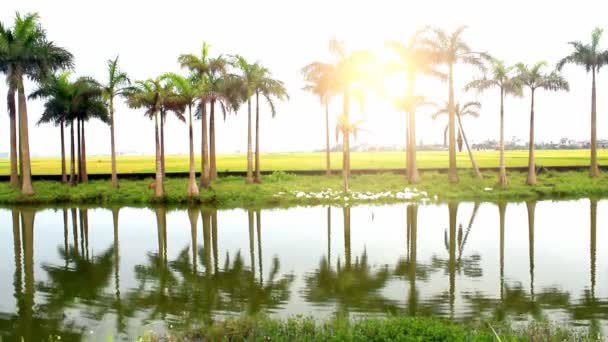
0 0 608 155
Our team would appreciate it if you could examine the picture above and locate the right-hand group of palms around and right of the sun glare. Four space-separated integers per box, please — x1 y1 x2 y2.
302 26 608 191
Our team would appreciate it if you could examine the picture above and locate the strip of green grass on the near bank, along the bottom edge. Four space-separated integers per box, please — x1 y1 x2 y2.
138 317 601 342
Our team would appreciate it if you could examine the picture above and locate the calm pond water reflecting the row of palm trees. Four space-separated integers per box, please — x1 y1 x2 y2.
0 199 608 341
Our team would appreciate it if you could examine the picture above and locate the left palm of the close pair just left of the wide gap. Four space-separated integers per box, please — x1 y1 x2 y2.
234 55 262 184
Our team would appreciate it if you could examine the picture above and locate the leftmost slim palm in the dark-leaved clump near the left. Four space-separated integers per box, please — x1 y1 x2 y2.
29 72 72 183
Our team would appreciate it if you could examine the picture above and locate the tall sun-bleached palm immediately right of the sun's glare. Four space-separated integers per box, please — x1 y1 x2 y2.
387 31 445 183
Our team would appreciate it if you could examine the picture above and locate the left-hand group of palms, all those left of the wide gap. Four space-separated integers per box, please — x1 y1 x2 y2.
0 14 289 197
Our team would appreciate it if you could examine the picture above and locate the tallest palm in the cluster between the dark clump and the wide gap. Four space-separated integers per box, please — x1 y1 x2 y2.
178 42 225 188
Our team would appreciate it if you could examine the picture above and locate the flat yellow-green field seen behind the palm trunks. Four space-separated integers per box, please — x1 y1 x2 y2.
0 149 608 178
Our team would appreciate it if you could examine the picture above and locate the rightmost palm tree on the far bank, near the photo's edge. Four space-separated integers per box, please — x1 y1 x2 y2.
557 28 608 177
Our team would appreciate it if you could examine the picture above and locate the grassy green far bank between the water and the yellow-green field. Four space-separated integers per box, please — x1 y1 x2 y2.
0 171 608 207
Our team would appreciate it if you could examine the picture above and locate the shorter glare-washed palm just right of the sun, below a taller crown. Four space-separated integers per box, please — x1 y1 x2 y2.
395 94 433 180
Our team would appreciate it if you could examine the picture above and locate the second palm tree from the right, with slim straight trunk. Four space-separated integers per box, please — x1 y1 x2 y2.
516 62 570 185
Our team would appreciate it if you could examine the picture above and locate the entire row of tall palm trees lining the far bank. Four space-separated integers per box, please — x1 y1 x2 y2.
0 14 608 197
